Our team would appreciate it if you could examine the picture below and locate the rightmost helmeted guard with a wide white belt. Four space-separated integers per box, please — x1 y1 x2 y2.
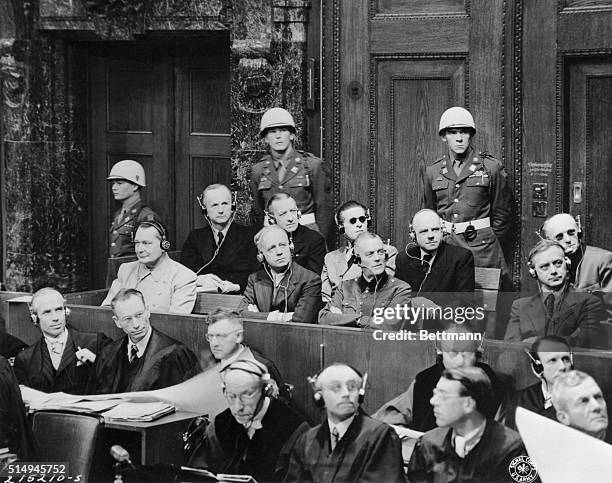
425 107 514 278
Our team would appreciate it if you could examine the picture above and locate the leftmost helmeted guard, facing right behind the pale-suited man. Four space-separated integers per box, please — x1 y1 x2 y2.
106 159 161 260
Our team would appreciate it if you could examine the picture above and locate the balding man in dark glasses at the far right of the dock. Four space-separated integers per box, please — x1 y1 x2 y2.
542 213 612 318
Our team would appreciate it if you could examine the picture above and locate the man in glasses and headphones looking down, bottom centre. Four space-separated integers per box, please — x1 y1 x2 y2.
187 359 308 481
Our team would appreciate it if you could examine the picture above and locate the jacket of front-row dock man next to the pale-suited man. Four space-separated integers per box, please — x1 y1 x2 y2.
238 263 321 324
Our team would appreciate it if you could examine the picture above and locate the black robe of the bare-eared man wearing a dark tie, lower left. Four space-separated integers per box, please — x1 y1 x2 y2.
89 329 200 394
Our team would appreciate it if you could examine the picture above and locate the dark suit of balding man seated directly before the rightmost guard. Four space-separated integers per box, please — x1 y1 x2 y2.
395 241 475 306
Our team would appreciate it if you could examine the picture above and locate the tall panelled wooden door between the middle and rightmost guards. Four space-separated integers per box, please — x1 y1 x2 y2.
326 0 506 258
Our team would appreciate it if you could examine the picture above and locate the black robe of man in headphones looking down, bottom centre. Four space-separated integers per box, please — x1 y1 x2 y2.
187 399 309 482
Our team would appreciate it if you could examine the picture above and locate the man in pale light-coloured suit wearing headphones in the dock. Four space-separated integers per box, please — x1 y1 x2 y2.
101 221 197 314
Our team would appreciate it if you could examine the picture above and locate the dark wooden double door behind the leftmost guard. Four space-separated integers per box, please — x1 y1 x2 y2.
87 35 231 288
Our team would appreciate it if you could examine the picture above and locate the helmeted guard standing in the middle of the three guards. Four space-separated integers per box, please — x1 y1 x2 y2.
251 107 331 237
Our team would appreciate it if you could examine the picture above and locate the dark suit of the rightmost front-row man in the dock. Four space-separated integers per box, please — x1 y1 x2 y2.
504 288 605 347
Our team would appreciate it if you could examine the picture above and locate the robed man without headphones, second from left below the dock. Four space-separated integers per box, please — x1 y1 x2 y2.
89 289 200 394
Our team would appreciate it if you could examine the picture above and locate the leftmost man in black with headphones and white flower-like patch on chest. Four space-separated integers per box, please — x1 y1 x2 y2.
15 287 111 394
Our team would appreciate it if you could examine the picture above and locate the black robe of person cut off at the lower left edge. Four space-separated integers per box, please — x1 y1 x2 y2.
0 356 36 461
